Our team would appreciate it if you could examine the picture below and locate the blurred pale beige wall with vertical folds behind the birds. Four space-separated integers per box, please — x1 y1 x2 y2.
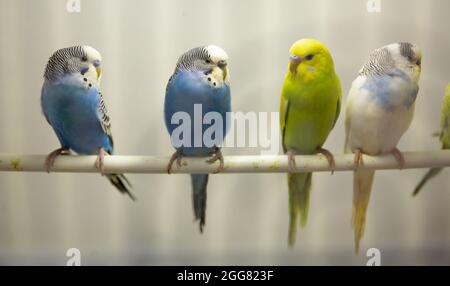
0 0 450 265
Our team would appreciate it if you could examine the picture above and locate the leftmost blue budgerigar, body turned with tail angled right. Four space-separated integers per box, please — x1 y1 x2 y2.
41 46 135 200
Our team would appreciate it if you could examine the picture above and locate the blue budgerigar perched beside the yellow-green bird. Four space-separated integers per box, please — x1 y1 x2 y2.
164 45 231 232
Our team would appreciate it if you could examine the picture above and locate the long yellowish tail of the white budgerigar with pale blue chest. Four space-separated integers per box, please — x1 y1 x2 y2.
352 170 375 253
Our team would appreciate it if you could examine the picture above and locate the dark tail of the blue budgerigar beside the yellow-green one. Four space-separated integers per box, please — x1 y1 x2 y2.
191 174 209 233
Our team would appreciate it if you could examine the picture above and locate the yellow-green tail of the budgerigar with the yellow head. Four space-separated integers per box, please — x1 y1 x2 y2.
288 173 312 247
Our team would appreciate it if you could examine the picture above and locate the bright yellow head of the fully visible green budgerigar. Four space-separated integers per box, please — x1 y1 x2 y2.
288 39 334 82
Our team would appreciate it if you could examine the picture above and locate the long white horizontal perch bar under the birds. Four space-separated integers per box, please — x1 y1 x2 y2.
0 150 450 174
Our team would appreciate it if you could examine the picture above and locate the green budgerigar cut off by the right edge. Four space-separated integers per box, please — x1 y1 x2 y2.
413 84 450 196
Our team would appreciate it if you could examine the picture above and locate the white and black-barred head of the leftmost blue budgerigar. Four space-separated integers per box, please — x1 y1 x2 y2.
44 46 102 83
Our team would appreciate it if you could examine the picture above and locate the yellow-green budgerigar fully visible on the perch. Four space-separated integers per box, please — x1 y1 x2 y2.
280 39 342 247
